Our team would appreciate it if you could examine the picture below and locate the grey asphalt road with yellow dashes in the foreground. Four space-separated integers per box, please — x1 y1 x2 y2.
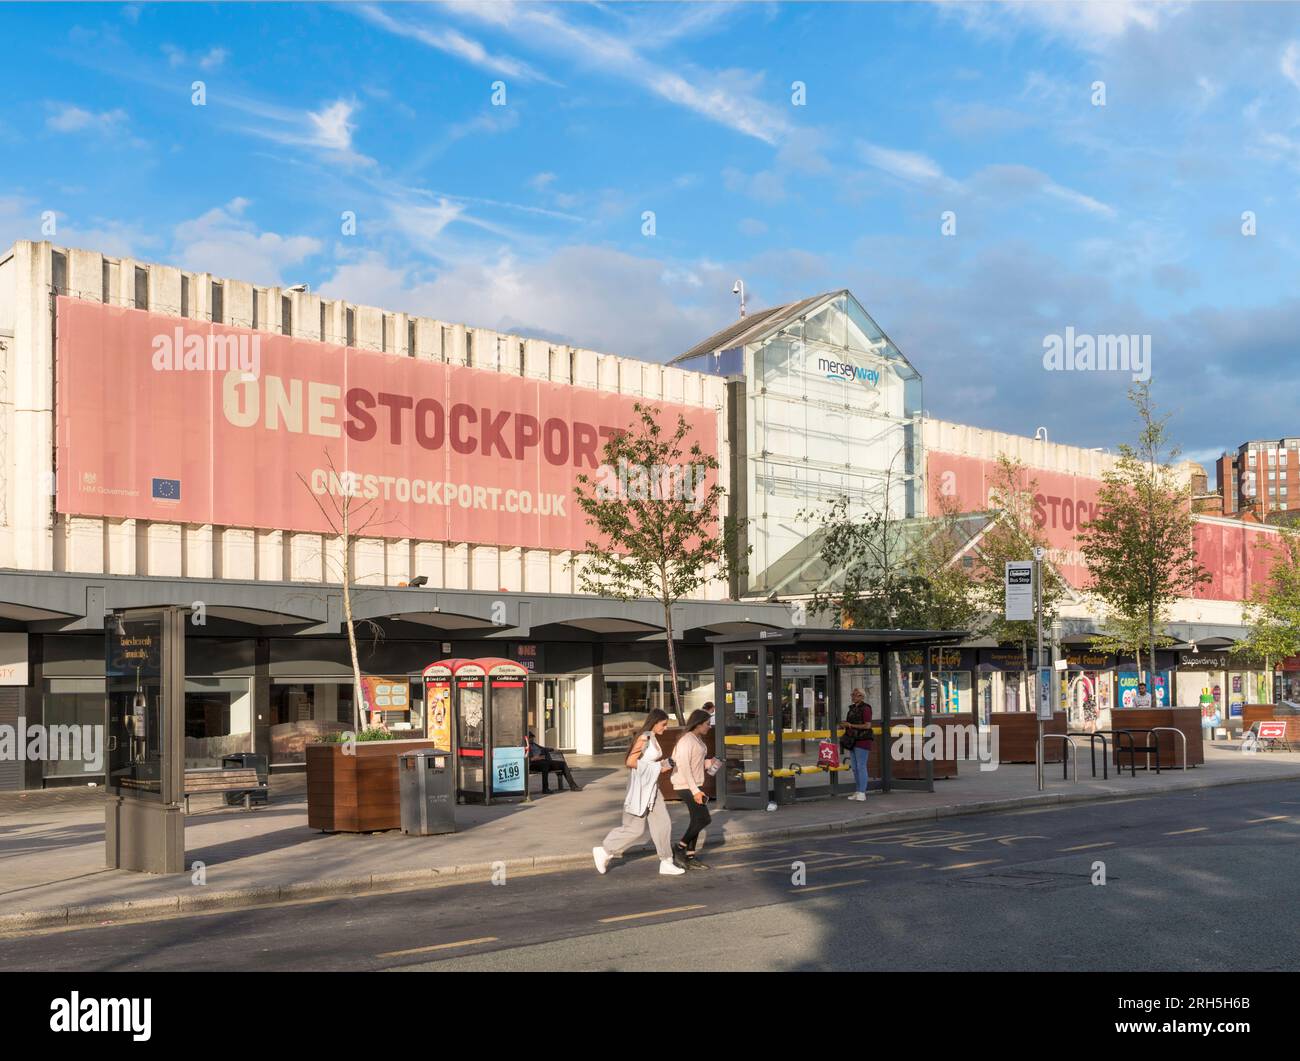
0 781 1300 971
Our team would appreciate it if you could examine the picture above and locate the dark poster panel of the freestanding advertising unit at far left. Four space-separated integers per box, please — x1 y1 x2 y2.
104 616 164 801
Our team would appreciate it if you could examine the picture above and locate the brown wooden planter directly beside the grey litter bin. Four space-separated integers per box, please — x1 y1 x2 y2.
307 740 434 832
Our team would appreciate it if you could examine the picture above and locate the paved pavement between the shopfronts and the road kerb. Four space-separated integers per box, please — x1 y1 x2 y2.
0 745 1300 931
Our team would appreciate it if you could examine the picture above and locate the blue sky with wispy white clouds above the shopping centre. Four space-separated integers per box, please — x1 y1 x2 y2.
0 3 1300 460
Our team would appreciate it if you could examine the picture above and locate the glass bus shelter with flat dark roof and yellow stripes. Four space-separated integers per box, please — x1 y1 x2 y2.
709 627 969 809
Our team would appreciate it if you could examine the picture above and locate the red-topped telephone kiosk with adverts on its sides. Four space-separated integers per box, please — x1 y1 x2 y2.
423 657 528 804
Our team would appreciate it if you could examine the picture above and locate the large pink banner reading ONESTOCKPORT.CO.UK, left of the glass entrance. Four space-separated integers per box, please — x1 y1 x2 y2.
56 296 718 550
